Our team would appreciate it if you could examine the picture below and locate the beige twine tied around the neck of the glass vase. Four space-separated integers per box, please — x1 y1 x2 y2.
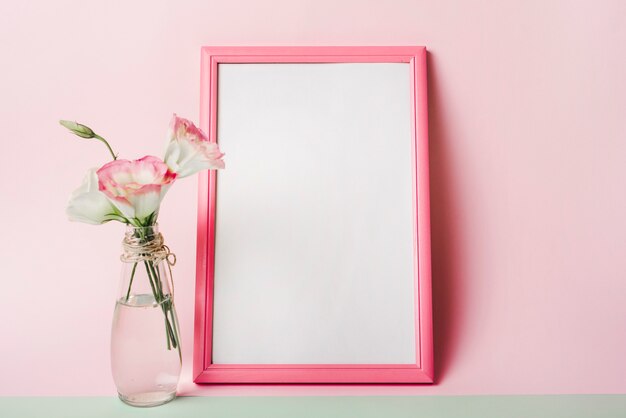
120 232 176 299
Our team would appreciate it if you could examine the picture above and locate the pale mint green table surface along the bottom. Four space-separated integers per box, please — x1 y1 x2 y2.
0 395 626 418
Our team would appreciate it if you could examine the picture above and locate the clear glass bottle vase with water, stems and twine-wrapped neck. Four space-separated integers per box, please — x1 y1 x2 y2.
111 225 182 406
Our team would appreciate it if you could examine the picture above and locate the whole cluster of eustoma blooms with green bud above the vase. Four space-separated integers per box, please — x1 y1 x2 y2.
59 115 224 226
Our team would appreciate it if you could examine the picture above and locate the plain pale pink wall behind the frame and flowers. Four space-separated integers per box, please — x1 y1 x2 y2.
0 0 626 395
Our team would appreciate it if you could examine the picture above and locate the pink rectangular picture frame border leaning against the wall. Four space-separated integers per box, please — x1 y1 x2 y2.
193 46 434 384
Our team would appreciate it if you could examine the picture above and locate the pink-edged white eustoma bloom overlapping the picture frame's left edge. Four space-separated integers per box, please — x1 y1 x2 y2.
164 114 224 178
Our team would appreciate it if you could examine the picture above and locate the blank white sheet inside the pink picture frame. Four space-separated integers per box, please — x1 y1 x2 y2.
213 63 416 364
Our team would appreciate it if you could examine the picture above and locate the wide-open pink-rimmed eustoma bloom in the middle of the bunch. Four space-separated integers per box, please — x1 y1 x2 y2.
97 156 177 225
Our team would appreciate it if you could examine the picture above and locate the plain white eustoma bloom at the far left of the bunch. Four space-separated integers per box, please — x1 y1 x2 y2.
66 168 126 225
